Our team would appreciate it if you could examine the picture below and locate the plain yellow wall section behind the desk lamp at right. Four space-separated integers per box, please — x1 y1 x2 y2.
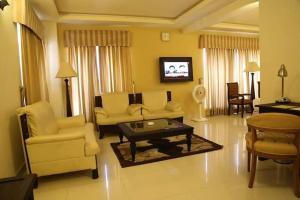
260 0 300 102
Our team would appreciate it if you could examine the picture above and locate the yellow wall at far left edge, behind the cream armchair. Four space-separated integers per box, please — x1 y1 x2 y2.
0 1 24 178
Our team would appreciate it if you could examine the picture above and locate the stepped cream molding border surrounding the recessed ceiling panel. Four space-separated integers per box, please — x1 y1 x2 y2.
30 0 259 33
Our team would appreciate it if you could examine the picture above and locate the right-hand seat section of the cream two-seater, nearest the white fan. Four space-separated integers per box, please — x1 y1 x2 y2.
142 91 184 122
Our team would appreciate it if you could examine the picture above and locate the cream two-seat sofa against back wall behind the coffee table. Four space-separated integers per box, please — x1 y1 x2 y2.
95 91 183 138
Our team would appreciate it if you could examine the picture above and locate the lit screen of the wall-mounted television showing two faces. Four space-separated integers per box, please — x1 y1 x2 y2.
164 62 189 77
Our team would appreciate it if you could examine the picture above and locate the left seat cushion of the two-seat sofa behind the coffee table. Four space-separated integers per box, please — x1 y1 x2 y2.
96 113 143 125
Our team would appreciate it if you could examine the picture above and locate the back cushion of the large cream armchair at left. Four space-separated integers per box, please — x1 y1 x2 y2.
17 101 58 136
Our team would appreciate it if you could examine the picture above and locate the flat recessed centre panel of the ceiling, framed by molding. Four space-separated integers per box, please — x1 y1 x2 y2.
55 0 202 18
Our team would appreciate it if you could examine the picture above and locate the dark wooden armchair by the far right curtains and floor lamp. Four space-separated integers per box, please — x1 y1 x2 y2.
227 82 254 117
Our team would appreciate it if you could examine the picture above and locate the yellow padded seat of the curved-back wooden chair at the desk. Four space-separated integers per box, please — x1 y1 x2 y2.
246 132 297 155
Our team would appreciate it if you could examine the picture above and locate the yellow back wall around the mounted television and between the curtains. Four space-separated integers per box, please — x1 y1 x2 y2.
58 24 202 117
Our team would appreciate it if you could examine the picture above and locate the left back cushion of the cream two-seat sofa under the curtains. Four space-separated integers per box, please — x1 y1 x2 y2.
101 92 129 114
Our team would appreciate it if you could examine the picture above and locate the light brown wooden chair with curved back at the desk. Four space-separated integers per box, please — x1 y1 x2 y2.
246 113 300 197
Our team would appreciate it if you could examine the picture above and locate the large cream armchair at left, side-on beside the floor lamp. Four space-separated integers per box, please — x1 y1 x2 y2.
17 101 99 178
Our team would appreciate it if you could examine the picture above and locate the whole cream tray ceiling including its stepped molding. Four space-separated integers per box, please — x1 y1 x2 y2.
30 0 259 32
